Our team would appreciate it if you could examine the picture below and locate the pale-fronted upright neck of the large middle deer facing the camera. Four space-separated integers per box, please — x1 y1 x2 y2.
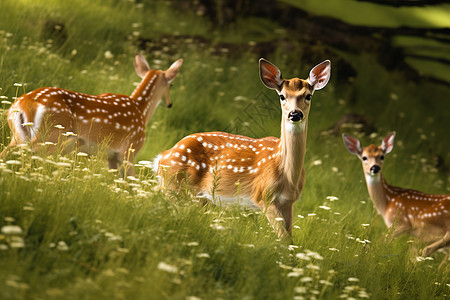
279 117 308 187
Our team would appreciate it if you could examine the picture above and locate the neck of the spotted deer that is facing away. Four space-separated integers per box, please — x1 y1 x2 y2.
131 70 164 124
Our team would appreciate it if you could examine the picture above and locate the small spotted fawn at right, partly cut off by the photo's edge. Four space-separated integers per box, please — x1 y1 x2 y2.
343 132 450 256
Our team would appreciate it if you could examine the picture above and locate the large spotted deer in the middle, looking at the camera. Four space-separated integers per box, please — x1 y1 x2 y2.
154 59 331 238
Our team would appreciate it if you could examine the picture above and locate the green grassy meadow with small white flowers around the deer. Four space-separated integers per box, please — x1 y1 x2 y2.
0 0 450 300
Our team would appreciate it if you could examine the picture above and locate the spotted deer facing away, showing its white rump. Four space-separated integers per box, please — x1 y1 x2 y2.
0 54 183 174
